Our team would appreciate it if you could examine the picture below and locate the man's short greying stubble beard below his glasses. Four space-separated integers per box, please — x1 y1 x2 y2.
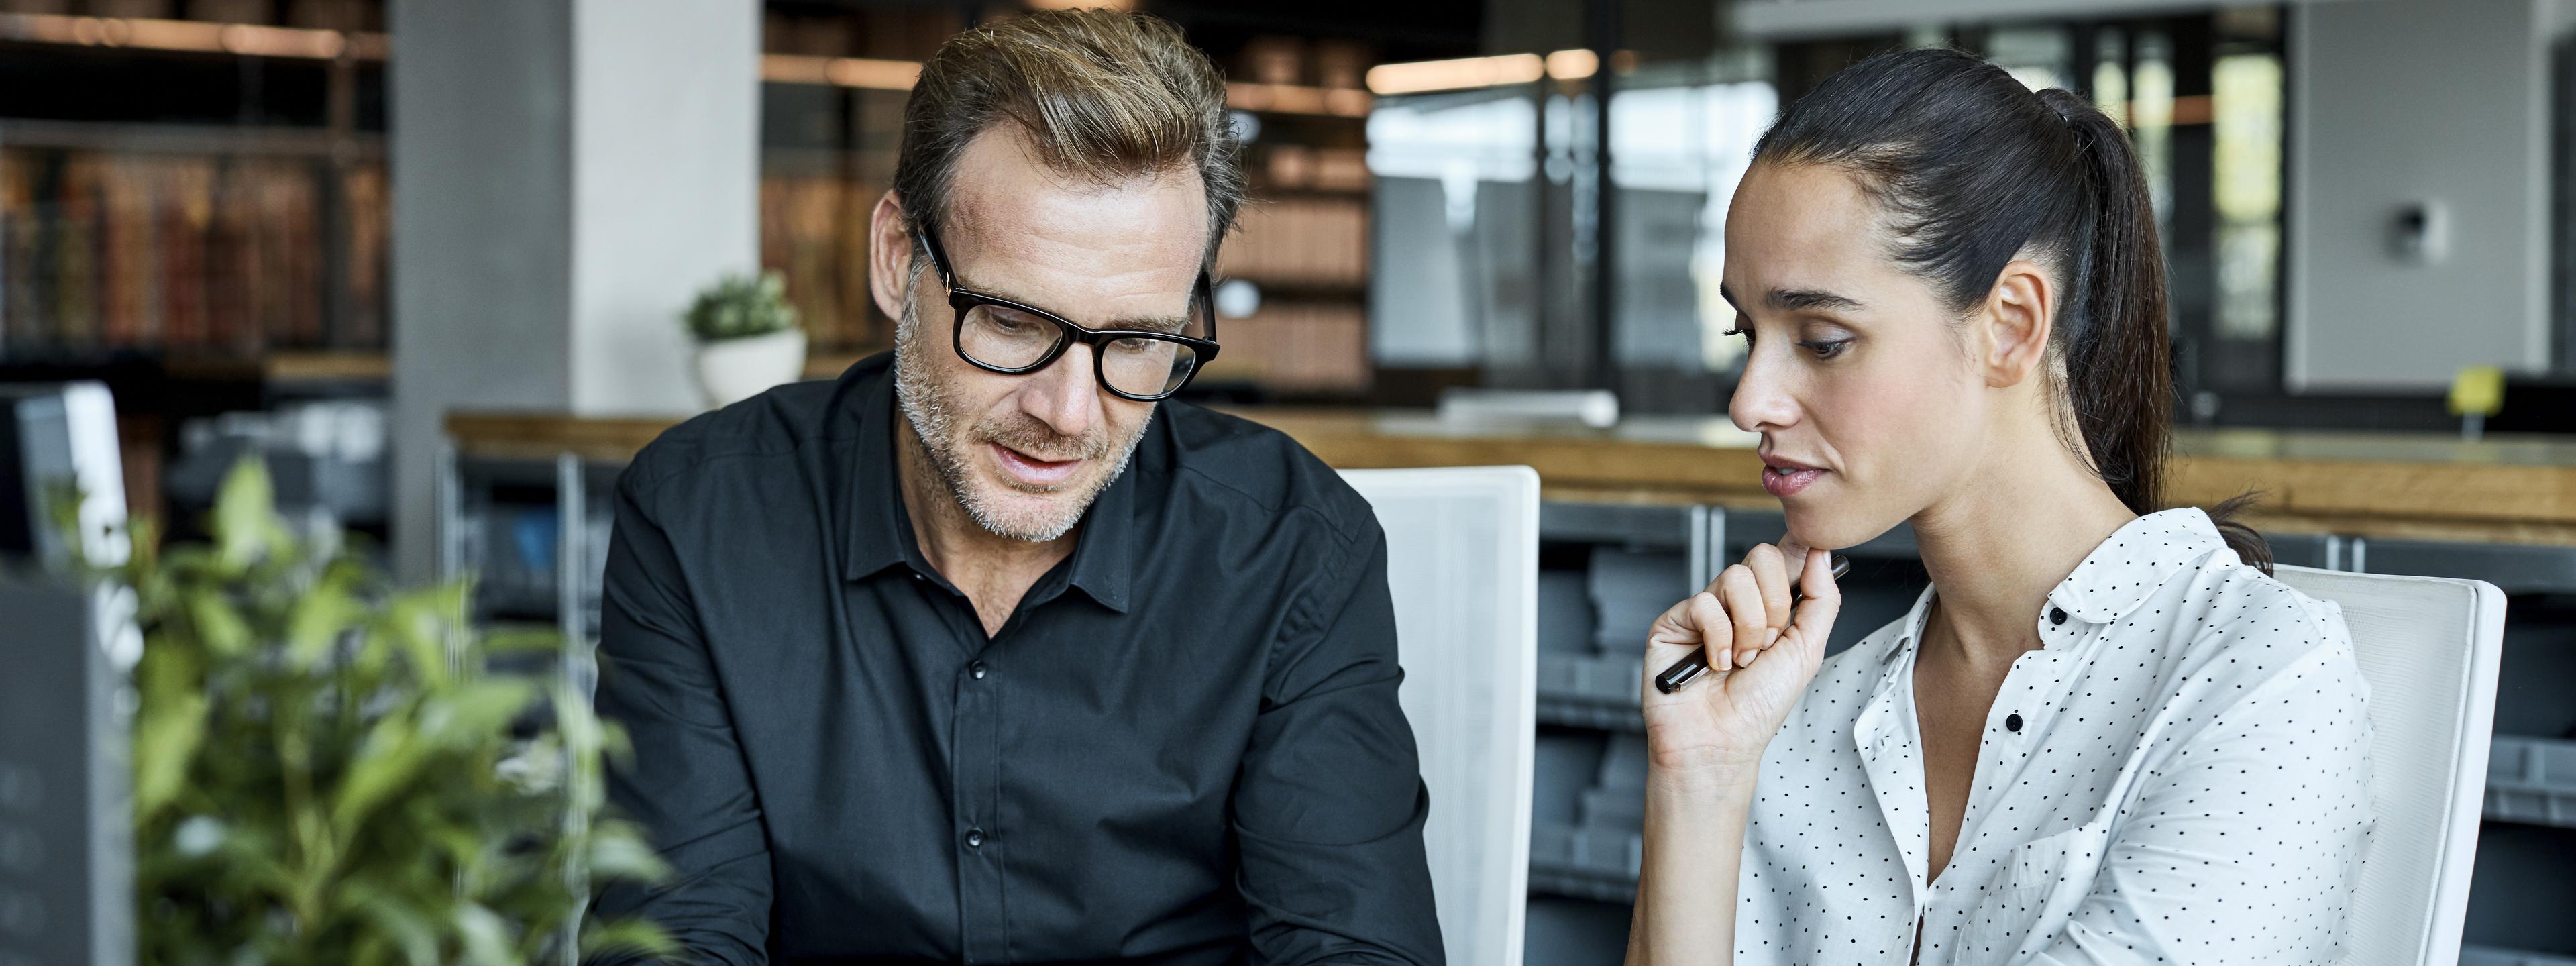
894 299 1154 543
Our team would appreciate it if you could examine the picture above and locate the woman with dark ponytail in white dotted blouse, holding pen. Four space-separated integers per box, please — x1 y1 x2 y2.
1628 49 2370 966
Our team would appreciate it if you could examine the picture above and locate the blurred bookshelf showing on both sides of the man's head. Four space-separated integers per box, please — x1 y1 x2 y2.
760 8 1373 399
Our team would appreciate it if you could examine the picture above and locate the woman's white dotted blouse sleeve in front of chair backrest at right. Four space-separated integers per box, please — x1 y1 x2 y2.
2035 631 2370 963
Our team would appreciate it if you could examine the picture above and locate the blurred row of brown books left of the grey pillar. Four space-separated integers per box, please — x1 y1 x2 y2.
0 147 392 356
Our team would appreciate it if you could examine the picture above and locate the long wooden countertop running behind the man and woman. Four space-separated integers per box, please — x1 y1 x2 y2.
448 410 2576 546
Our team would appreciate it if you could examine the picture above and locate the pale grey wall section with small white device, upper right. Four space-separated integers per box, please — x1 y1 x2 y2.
2282 0 2561 392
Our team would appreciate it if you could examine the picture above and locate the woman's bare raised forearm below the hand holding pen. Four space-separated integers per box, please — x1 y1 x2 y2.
1628 765 1757 966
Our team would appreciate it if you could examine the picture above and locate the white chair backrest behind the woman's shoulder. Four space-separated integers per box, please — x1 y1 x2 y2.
2277 567 2504 966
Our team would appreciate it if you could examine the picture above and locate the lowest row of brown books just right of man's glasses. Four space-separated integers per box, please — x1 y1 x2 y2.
1205 299 1371 394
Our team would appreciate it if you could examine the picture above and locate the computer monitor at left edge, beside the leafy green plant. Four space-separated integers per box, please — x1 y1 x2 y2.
0 384 142 966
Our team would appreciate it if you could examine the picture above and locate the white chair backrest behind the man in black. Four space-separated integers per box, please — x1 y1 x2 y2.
1342 466 1538 966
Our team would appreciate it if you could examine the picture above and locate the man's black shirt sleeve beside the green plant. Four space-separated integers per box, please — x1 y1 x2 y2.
598 472 770 966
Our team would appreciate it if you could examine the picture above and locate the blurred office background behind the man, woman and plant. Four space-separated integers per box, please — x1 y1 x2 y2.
0 0 2576 963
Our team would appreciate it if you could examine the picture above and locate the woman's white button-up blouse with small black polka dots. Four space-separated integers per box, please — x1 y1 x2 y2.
1736 510 2370 966
